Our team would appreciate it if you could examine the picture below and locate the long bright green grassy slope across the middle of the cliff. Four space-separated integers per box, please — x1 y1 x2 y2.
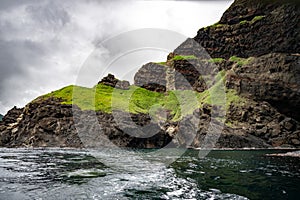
40 71 245 121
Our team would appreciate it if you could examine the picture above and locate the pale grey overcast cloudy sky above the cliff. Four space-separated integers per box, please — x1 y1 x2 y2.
0 0 232 114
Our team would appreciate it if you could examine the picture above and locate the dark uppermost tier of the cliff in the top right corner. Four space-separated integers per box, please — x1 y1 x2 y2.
194 0 300 59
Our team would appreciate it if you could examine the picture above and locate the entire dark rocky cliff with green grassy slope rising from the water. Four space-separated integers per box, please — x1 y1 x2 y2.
0 0 300 148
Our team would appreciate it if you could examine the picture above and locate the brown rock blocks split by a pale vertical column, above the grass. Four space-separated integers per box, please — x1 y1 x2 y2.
134 55 218 92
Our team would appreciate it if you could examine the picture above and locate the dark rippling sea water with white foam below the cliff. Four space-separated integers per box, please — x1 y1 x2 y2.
0 148 300 200
